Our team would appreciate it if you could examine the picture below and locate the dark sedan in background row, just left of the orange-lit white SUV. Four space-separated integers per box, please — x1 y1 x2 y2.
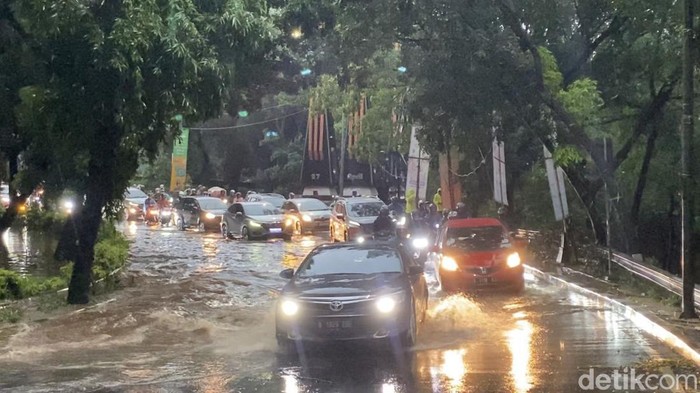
221 202 284 240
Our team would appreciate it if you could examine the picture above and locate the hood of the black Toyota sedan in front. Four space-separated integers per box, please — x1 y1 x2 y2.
284 273 405 297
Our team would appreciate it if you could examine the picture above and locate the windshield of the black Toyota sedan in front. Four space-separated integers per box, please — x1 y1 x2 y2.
297 247 402 277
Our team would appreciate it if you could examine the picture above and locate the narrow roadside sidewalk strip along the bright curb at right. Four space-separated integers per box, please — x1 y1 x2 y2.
528 258 700 366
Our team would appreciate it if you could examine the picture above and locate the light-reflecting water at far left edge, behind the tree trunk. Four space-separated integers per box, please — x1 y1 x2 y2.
0 227 60 276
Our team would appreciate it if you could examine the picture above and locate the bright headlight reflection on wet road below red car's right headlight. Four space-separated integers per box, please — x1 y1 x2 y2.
506 319 532 393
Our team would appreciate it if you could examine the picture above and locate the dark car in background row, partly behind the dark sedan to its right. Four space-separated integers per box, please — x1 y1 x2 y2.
173 196 228 231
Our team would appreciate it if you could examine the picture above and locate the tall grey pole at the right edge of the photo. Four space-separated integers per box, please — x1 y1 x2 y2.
680 0 698 319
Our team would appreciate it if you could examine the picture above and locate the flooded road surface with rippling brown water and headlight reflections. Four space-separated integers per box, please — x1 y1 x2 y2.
0 224 692 393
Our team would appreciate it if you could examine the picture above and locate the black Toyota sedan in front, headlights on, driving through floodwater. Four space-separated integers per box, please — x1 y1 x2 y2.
276 243 428 352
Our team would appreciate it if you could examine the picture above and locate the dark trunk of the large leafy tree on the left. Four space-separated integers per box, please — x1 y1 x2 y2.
68 123 121 304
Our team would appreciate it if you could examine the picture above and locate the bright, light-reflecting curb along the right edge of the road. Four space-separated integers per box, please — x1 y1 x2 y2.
525 265 700 366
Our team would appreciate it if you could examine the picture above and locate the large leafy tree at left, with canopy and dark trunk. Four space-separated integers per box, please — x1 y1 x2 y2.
13 0 275 304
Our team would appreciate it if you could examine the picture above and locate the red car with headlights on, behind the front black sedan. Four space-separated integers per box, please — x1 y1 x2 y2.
434 218 525 292
